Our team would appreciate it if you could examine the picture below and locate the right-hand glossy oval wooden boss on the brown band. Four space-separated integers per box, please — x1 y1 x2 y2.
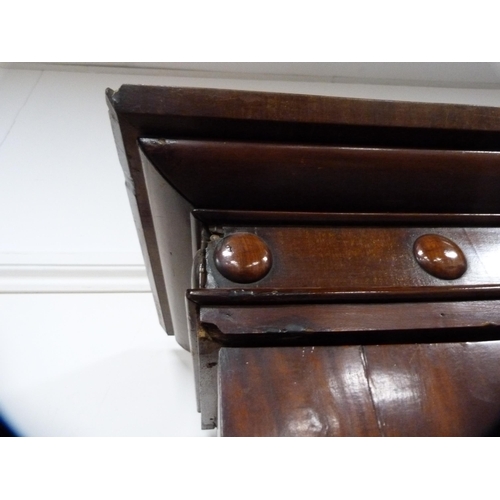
413 234 467 280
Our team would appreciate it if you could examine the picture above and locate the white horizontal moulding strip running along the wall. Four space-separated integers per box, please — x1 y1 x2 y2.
0 265 151 293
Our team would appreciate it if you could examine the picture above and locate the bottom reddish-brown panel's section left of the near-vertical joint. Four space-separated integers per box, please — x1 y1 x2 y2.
219 347 379 436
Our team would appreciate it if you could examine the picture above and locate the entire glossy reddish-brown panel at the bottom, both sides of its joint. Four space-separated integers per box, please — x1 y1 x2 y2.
219 342 500 436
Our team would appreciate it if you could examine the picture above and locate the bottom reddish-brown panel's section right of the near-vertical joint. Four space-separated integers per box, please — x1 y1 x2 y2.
364 342 500 436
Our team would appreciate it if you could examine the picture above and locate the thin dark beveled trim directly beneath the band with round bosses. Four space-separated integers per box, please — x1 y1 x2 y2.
186 284 500 306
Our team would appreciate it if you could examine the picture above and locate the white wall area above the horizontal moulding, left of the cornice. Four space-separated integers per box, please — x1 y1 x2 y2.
0 74 142 264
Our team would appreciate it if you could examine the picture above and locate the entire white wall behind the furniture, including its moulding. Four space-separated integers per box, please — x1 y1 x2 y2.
0 65 500 436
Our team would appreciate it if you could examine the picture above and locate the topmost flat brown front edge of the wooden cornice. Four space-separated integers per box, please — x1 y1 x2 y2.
109 84 500 131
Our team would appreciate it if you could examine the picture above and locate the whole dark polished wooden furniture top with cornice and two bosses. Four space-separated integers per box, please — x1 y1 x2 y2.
107 85 500 436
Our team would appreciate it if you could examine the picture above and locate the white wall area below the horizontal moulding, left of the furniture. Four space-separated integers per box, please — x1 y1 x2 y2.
0 293 215 436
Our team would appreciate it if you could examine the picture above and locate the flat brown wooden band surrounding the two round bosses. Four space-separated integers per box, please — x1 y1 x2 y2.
207 227 500 290
